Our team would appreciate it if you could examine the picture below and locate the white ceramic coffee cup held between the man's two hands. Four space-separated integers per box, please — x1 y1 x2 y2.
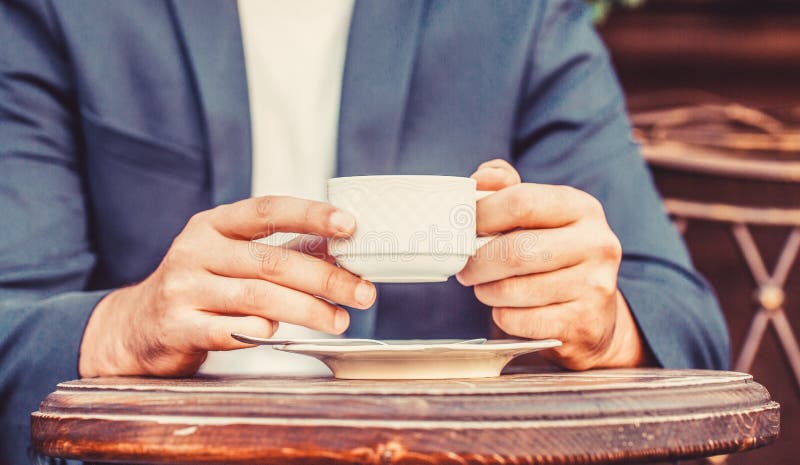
328 175 493 283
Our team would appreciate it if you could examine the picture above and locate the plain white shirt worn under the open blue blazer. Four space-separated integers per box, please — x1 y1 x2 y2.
201 0 354 373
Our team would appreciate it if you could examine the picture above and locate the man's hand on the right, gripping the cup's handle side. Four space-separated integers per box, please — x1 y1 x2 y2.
457 160 646 370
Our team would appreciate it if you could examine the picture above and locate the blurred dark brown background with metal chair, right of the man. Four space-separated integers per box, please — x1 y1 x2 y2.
593 0 800 464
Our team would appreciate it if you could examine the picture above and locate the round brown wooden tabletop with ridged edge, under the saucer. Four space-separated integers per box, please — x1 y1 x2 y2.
32 369 780 465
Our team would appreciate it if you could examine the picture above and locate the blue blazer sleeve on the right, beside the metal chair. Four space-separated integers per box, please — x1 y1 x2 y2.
513 0 729 369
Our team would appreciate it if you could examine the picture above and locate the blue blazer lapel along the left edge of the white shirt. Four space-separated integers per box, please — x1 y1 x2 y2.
172 0 252 205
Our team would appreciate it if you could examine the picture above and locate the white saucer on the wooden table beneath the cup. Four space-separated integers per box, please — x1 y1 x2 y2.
274 339 561 379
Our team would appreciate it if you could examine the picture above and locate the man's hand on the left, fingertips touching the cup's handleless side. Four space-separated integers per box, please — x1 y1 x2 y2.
79 197 376 377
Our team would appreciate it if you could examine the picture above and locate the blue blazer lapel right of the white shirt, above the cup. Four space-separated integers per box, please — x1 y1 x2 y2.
337 0 424 176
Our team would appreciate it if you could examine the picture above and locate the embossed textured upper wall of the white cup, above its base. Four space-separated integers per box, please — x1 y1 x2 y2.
328 176 475 257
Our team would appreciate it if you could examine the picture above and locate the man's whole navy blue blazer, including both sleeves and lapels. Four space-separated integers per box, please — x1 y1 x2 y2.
0 0 728 461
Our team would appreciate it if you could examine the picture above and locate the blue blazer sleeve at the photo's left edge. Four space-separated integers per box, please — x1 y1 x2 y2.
0 2 112 456
